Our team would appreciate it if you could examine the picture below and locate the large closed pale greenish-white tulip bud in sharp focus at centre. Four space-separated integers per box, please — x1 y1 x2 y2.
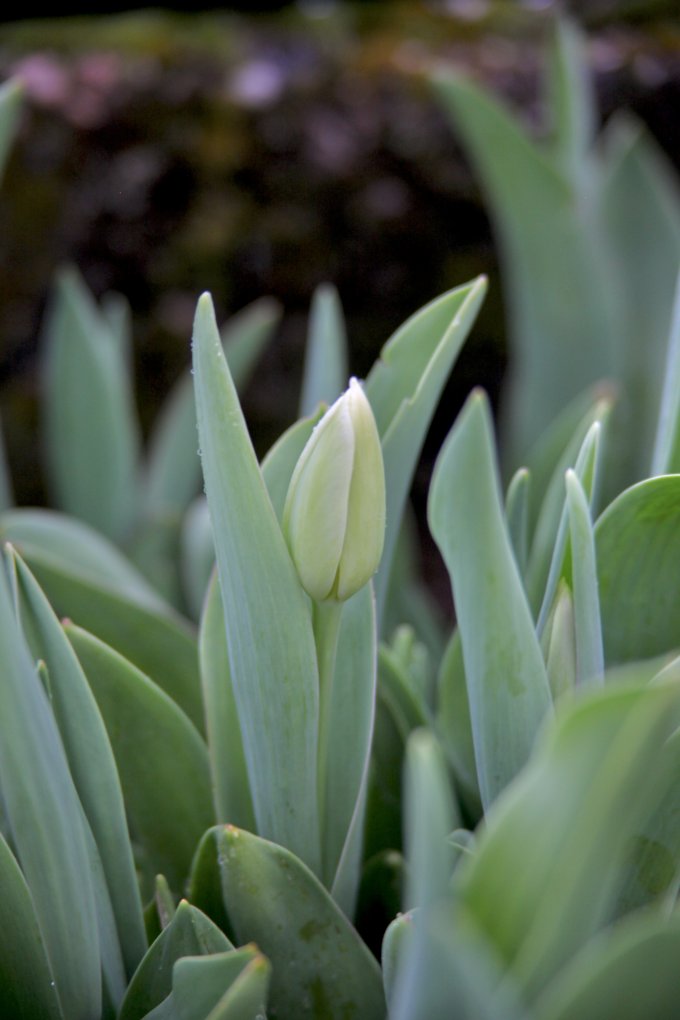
283 378 385 602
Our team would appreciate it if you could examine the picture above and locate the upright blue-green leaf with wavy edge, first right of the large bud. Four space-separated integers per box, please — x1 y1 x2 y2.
428 393 551 808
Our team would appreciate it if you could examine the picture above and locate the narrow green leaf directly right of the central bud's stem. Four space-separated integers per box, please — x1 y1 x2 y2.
321 584 376 917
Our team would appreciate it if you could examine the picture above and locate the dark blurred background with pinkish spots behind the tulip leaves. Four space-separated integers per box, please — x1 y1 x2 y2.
0 0 680 599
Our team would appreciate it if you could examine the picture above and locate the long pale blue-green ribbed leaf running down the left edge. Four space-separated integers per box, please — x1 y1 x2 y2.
0 570 101 1020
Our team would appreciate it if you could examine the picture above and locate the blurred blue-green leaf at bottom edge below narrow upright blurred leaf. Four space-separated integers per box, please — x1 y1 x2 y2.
389 901 528 1020
